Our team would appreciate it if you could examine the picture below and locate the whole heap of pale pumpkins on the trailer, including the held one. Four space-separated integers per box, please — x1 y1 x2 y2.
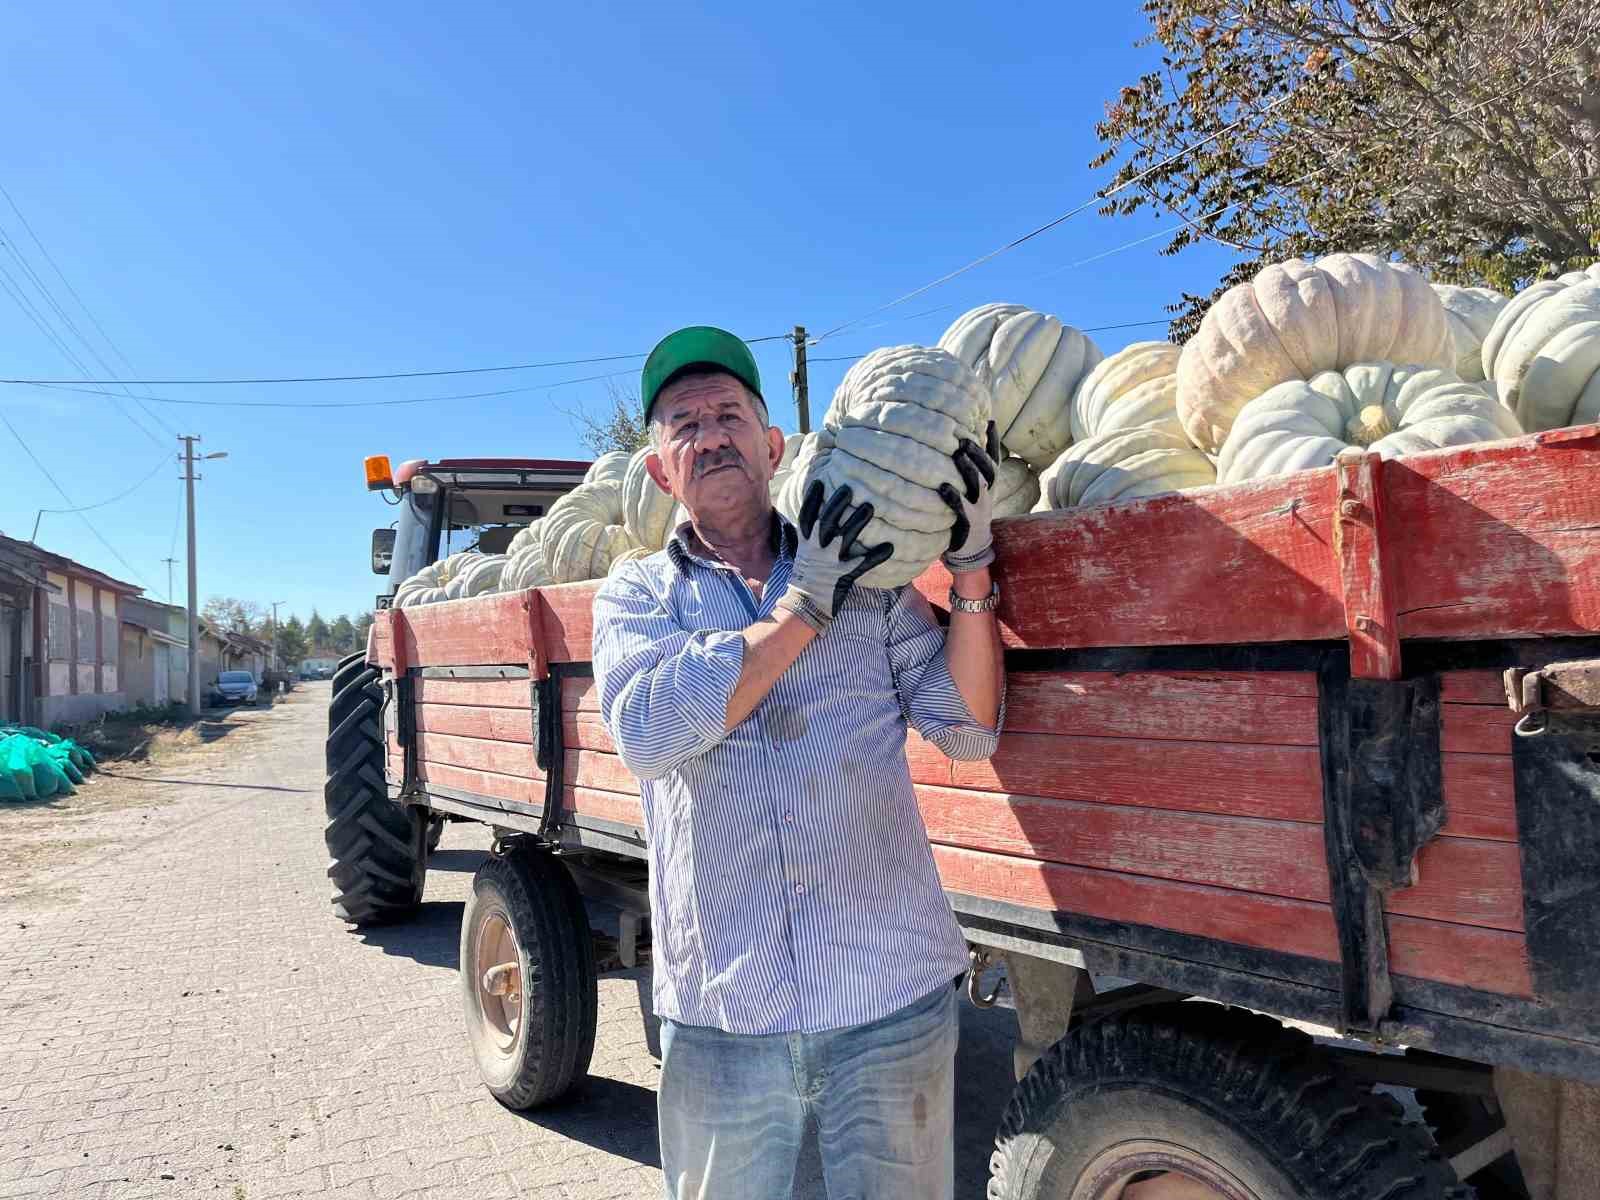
395 254 1600 603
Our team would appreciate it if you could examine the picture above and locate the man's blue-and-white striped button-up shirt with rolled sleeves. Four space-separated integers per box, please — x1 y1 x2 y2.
594 518 998 1034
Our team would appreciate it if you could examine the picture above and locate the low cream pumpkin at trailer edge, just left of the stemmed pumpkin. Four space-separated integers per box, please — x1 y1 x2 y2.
1034 424 1216 512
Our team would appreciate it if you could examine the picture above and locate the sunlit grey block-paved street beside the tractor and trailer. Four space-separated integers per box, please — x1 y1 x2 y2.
0 685 1014 1200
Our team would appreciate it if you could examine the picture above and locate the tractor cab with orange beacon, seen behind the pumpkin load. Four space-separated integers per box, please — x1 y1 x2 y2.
366 454 589 608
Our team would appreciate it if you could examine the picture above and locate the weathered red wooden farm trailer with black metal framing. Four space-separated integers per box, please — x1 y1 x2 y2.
330 426 1600 1197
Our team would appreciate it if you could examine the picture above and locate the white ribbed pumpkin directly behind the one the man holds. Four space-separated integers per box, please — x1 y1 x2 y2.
939 304 1104 470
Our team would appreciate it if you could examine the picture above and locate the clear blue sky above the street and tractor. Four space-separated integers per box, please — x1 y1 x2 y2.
0 0 1227 630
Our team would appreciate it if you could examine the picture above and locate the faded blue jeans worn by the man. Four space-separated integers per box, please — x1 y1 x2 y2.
659 984 957 1200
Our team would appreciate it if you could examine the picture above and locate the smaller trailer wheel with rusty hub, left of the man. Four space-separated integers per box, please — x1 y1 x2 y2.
461 848 600 1110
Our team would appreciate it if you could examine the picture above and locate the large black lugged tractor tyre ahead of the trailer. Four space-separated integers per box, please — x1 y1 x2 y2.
323 656 427 925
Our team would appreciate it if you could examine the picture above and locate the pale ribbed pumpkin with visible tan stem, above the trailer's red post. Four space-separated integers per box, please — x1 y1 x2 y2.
1218 363 1522 483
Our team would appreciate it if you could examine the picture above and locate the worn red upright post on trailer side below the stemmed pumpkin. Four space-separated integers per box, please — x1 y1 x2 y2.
1333 446 1400 680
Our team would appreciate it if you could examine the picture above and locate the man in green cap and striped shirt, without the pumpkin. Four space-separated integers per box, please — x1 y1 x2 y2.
594 326 1003 1200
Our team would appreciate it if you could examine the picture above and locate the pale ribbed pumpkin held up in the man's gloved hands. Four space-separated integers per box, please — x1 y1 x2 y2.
806 346 989 587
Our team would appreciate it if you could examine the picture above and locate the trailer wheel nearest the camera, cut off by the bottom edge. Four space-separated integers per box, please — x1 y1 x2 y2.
989 1003 1472 1200
